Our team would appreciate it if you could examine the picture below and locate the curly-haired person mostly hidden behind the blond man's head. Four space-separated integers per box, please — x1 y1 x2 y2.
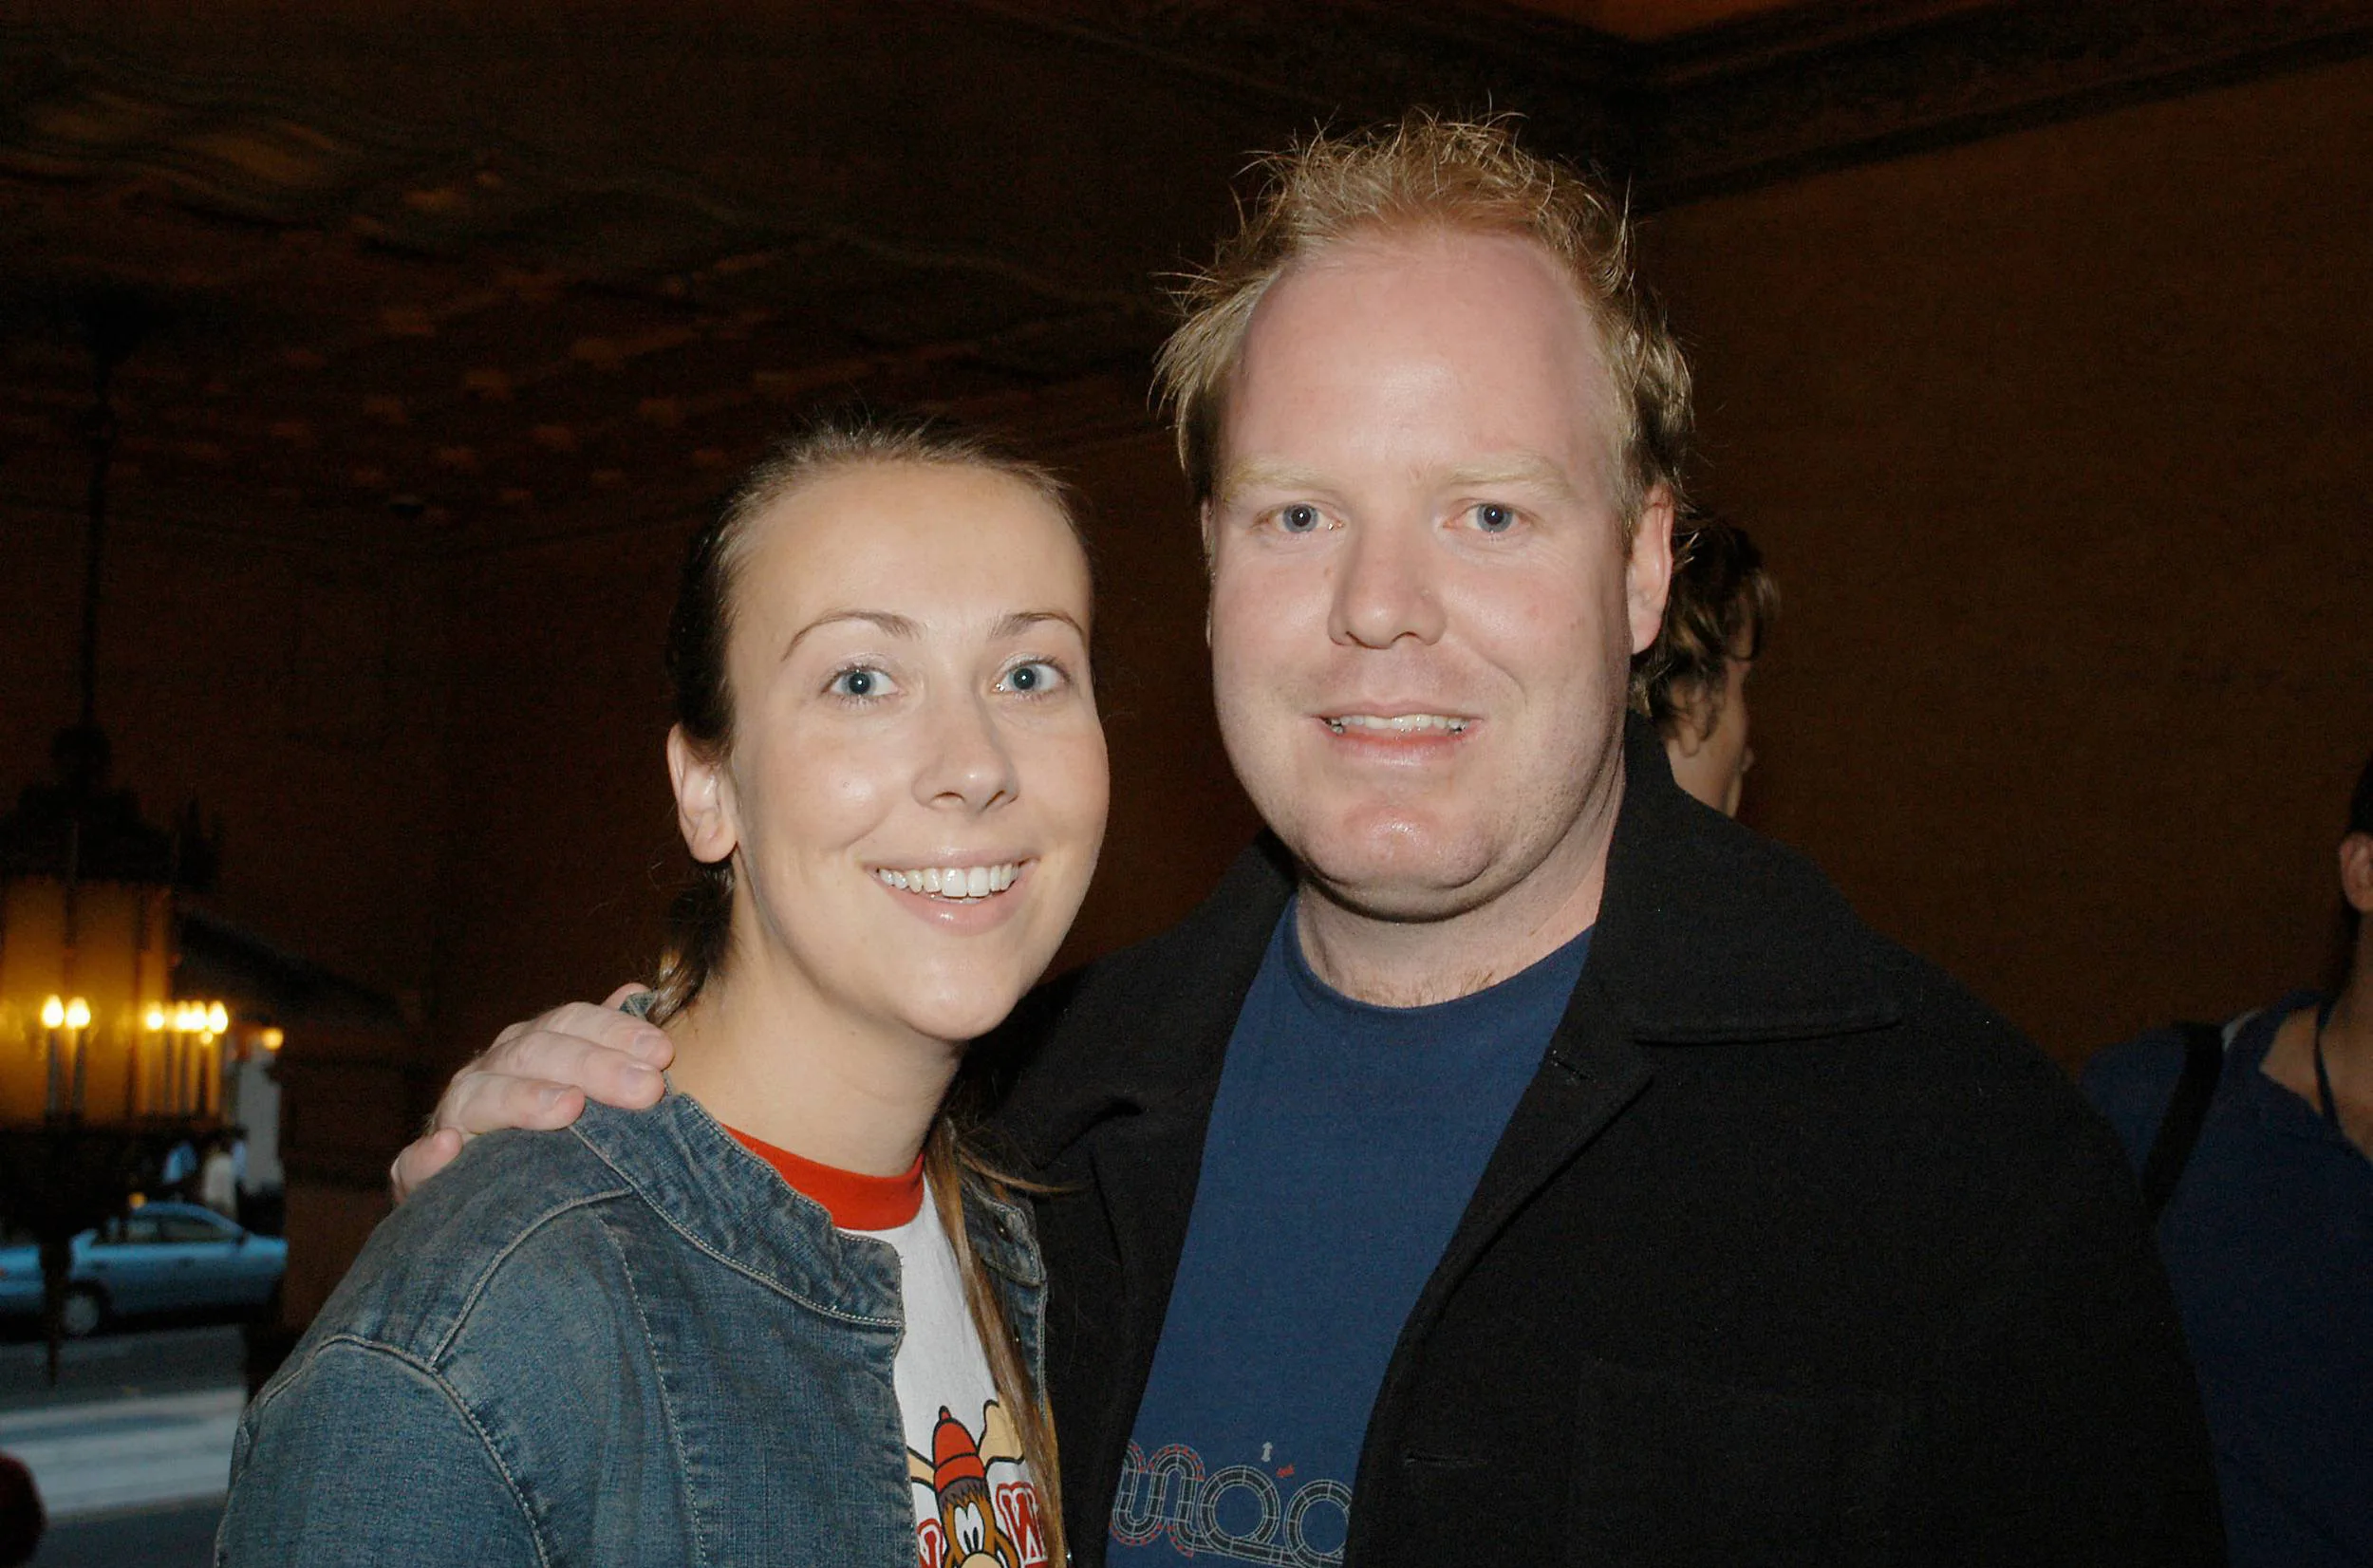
1633 517 1780 816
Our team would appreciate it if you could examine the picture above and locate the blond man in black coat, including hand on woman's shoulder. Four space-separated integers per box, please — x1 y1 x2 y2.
397 116 2216 1566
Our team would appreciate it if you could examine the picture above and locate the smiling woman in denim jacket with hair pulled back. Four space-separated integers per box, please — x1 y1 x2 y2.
218 415 1106 1568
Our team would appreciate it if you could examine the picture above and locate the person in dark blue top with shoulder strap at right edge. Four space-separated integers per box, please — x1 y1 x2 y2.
2083 744 2373 1568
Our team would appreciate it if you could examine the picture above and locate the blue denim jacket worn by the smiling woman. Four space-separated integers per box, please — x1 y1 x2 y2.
214 1093 1044 1568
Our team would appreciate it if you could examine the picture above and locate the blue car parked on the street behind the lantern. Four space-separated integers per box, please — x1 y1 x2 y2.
0 1203 290 1338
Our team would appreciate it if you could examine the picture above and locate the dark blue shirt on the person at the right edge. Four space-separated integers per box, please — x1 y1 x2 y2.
2083 992 2373 1568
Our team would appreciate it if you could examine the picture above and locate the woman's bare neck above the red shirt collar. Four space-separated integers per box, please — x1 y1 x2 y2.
667 965 963 1177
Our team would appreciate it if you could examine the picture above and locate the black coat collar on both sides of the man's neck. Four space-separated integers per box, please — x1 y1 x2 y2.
1000 719 1901 1165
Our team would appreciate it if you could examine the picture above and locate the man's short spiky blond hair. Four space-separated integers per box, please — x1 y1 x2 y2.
1153 111 1690 522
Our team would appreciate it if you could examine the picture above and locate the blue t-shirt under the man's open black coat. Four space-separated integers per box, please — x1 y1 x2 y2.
1109 906 1590 1566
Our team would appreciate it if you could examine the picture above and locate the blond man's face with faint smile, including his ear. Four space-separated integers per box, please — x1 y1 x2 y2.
1204 233 1671 921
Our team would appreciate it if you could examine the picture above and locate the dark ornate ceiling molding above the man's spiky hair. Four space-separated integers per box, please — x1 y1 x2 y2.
966 0 2373 206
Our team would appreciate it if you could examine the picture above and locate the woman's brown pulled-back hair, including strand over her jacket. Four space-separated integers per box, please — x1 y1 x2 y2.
650 415 1085 1566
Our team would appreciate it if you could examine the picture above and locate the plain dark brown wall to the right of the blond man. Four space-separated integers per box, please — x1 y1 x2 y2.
1652 62 2373 1063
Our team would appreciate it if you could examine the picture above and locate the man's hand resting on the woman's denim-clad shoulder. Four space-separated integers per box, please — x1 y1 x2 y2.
387 984 677 1203
